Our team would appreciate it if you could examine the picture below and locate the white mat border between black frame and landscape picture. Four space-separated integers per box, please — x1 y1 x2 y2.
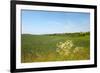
16 5 94 69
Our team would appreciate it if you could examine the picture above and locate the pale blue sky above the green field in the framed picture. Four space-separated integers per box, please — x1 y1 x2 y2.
21 10 90 34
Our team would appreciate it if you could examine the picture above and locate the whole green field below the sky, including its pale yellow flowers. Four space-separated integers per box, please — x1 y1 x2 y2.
21 32 90 63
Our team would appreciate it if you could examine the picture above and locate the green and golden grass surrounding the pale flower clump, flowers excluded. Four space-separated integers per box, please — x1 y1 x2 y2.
21 33 90 62
